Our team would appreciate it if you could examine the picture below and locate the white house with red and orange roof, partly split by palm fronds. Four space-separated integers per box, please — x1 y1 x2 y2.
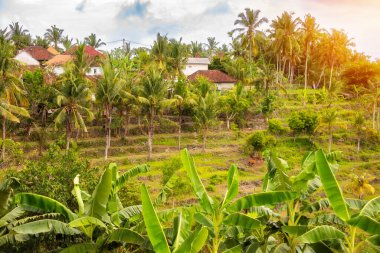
45 46 104 77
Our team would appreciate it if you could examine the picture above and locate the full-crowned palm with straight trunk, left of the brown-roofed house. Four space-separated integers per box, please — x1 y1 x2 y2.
138 65 167 160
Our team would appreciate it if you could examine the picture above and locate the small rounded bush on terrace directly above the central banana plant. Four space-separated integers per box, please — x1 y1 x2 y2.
246 131 276 153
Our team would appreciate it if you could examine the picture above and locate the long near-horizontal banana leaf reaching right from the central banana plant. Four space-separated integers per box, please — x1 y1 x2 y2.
228 191 297 212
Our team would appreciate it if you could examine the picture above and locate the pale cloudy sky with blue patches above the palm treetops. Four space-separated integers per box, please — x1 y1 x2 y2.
0 0 380 59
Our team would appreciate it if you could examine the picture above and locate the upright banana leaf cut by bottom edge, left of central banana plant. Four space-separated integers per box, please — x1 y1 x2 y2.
141 185 170 253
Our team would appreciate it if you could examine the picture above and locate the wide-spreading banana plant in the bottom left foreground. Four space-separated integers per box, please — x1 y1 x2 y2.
12 163 148 252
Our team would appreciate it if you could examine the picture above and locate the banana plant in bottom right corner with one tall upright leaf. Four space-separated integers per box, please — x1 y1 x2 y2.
298 150 380 253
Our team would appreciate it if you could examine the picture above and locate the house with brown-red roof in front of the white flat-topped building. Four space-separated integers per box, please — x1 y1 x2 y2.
187 70 236 90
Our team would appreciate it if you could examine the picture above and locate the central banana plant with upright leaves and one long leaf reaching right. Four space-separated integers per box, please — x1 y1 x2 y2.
181 149 297 253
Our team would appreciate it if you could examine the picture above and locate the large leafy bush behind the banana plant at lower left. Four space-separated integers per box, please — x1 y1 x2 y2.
7 144 99 210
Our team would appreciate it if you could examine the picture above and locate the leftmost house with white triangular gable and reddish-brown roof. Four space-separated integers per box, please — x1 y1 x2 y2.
15 46 54 68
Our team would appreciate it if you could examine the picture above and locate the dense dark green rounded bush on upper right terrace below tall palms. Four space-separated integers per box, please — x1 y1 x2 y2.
288 111 319 135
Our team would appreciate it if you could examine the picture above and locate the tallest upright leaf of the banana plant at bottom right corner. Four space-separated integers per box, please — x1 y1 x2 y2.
315 150 350 221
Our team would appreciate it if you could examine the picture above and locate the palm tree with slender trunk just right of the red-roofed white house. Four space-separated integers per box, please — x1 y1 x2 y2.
96 60 124 160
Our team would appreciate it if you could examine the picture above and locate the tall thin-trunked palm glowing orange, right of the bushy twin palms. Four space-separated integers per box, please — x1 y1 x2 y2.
301 14 319 98
